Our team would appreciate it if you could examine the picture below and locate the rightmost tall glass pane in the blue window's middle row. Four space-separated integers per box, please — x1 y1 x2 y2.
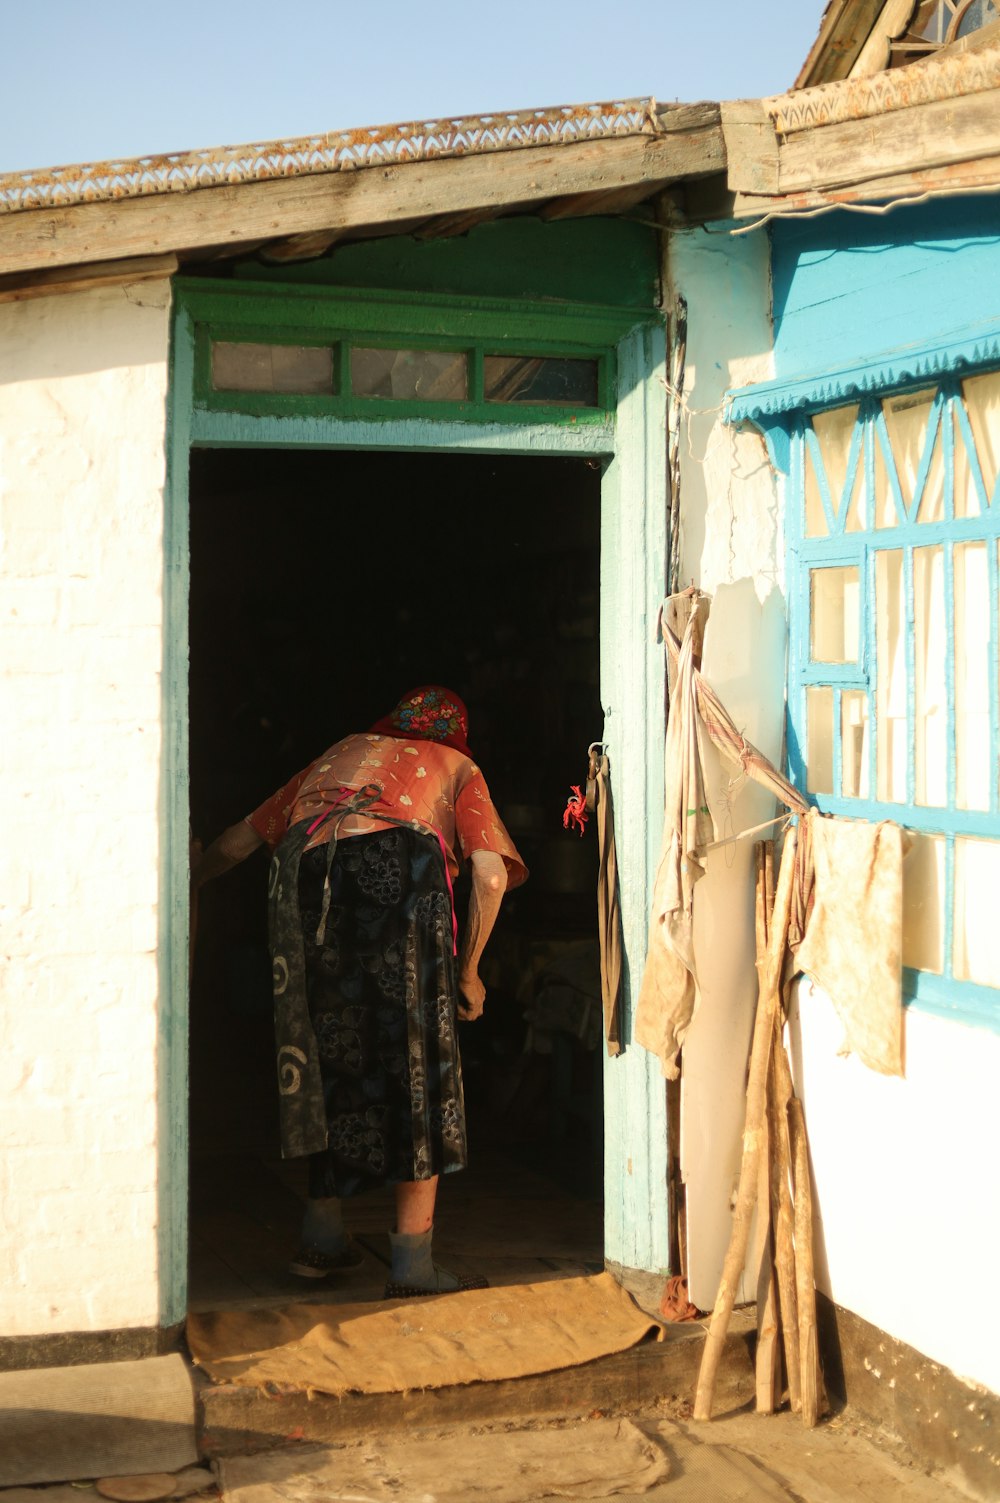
955 543 991 809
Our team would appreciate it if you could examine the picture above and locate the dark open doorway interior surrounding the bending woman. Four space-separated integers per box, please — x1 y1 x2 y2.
189 448 603 1308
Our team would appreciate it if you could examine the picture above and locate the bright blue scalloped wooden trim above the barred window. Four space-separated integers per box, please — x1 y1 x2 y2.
726 323 1000 428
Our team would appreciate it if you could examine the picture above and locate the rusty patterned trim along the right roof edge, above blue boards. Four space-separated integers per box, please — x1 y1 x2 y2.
762 50 1000 135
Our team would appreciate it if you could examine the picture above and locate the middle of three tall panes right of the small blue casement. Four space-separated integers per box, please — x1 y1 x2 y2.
913 544 947 806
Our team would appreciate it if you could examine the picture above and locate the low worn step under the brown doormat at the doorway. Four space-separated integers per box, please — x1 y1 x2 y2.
197 1311 755 1458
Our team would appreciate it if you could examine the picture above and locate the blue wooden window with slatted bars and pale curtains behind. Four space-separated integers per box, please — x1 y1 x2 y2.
732 367 1000 1028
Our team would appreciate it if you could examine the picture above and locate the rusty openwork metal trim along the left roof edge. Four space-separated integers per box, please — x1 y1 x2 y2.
0 99 662 213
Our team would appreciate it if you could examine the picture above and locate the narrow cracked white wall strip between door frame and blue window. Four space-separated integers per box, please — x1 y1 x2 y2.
668 227 785 1308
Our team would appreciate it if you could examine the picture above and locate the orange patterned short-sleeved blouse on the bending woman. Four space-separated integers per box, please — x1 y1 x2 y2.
247 732 528 890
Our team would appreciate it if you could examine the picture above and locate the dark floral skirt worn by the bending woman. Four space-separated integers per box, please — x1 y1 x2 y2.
298 827 466 1196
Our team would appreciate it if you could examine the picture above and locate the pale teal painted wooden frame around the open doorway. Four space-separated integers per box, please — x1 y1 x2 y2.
158 290 669 1326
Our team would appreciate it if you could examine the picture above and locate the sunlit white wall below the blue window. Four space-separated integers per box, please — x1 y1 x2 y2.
789 979 1000 1398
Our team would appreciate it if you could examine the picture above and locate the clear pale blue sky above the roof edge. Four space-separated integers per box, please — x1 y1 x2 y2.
0 0 824 173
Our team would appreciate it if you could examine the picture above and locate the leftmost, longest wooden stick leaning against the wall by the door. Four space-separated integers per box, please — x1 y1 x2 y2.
695 828 795 1420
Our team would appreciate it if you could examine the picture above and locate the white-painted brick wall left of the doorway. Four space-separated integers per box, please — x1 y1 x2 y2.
0 281 170 1336
